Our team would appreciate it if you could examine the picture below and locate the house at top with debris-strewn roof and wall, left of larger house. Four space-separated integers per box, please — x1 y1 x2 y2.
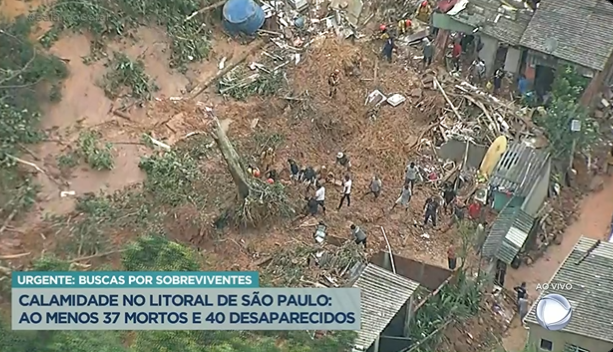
433 0 533 74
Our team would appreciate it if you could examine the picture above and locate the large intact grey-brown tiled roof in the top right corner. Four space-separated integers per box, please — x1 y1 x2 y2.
520 0 613 71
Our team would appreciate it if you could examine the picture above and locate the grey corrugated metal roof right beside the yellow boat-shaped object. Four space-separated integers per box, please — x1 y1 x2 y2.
490 143 549 197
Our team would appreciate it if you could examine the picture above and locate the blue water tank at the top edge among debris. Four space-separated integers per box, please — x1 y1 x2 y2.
223 0 266 35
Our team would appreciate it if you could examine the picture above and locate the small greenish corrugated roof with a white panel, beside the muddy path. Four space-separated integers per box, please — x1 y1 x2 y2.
482 208 534 264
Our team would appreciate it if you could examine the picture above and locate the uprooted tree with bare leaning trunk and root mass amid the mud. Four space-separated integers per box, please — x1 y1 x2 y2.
205 108 295 227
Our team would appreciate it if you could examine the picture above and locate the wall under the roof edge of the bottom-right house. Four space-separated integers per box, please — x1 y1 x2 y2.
528 323 613 352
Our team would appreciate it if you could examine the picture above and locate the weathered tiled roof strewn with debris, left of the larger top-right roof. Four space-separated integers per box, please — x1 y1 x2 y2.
452 0 532 45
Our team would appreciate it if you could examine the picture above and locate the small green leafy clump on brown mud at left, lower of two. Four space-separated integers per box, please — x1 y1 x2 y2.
76 130 115 170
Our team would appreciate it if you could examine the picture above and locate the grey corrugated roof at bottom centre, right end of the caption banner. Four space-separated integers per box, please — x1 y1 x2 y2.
353 264 419 350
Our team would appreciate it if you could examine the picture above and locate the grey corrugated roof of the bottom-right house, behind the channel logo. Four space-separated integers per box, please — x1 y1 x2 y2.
526 237 613 343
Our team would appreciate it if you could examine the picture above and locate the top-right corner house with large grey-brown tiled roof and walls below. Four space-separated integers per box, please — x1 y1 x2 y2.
519 0 613 103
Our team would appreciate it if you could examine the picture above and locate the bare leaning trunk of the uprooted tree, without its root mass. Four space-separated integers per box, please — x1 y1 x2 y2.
208 111 251 200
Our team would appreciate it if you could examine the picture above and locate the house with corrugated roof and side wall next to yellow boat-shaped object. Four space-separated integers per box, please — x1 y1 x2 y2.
489 142 551 216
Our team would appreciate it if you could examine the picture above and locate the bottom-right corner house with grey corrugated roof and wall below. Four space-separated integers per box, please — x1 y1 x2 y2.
525 237 613 352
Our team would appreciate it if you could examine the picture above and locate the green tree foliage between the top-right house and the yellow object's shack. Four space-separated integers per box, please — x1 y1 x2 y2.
534 65 598 160
